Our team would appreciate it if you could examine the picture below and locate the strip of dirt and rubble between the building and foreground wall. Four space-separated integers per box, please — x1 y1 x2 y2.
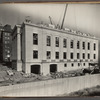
0 62 100 86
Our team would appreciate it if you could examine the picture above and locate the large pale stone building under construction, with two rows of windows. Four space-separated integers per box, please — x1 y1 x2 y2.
12 22 98 75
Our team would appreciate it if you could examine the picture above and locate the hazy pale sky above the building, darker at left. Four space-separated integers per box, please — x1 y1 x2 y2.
0 3 100 38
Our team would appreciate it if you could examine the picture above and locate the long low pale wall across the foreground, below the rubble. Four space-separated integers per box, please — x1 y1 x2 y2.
0 74 100 97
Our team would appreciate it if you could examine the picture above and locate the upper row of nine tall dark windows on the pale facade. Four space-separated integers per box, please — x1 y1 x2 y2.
33 33 96 50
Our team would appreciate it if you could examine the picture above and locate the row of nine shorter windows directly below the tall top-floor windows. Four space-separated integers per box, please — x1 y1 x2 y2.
33 50 96 59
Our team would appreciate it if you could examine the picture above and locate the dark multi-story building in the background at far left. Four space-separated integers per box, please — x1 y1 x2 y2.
0 24 12 62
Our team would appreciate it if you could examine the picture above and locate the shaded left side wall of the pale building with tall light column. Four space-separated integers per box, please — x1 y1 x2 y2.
11 25 22 71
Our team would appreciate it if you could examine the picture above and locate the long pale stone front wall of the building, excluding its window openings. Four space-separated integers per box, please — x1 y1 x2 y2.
22 24 98 74
